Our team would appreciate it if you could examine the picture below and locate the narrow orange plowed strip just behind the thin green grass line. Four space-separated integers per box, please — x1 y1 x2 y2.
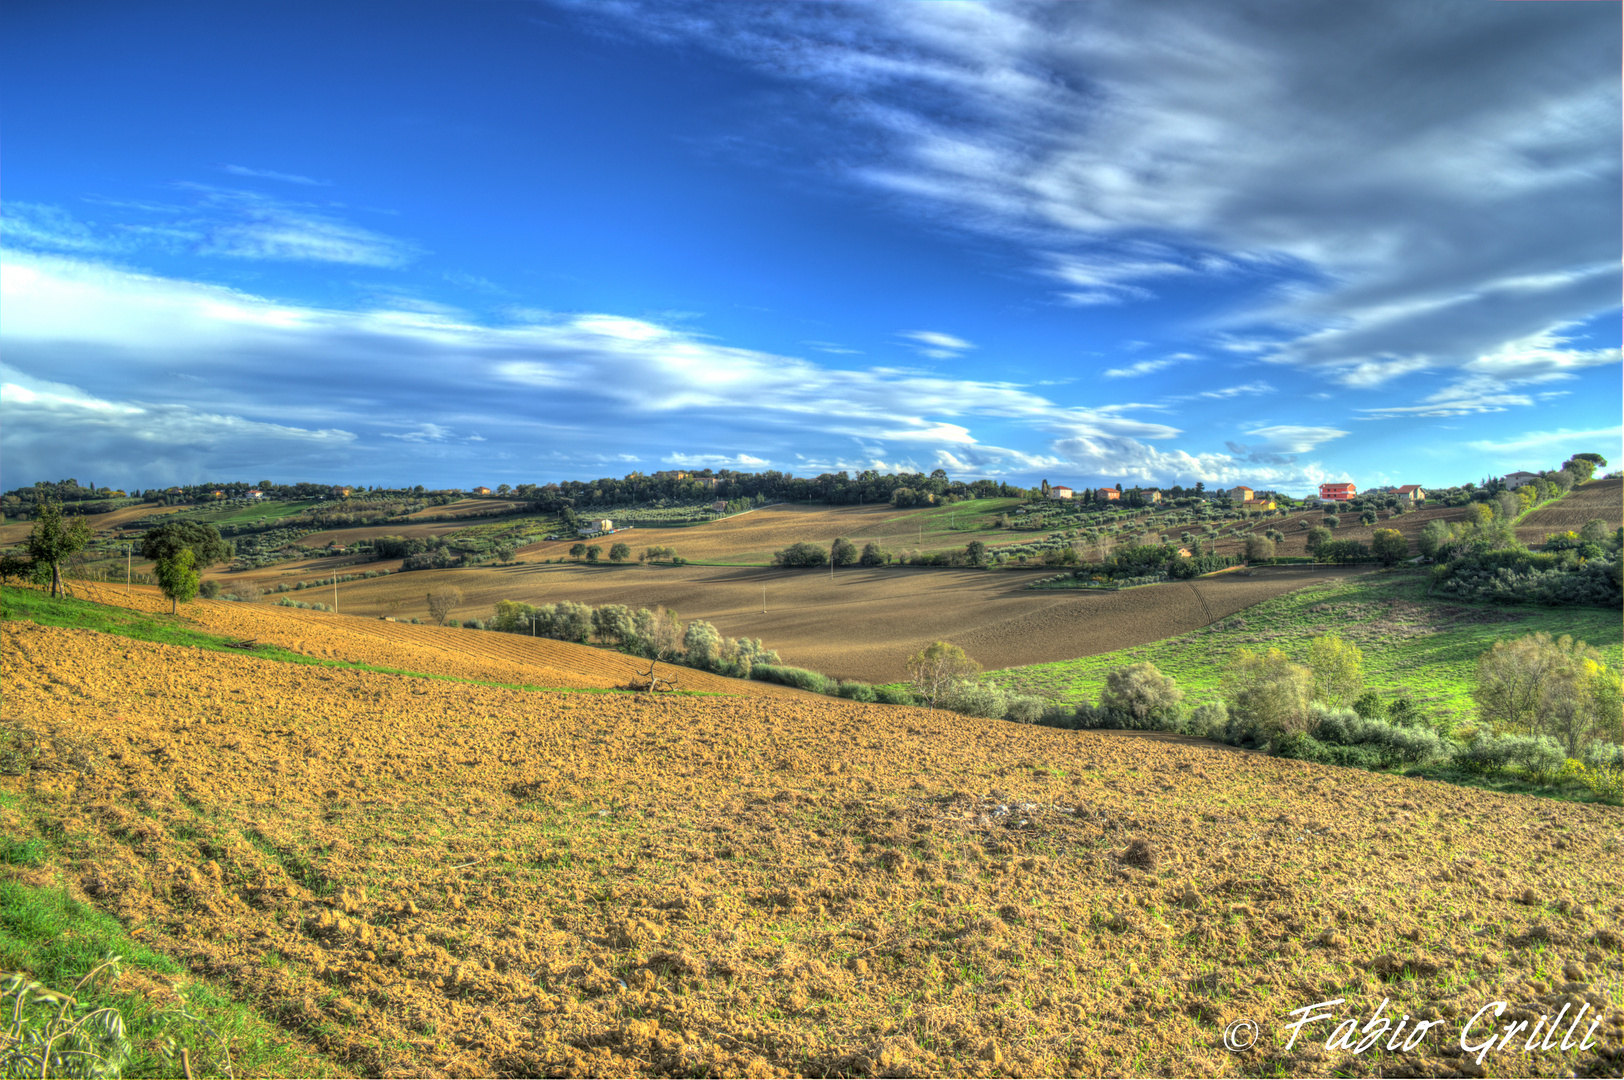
75 583 806 697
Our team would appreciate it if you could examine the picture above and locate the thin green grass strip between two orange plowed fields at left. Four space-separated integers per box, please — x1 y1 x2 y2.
0 588 731 697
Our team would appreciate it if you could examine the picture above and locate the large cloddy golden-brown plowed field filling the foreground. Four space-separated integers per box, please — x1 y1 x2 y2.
9 624 1624 1077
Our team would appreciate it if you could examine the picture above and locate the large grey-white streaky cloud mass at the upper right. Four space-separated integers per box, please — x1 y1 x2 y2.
562 0 1621 404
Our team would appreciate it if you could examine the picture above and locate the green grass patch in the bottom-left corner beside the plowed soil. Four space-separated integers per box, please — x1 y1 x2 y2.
0 880 343 1077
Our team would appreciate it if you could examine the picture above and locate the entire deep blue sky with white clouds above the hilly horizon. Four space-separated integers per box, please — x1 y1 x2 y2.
0 0 1624 494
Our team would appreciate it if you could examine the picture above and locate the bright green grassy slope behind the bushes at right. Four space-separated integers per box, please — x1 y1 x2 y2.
989 572 1624 713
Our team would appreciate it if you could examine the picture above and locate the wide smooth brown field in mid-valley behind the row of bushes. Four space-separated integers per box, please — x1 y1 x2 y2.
263 564 1358 682
